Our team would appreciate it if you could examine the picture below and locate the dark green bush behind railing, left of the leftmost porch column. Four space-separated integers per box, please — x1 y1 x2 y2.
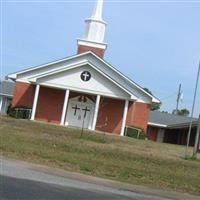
8 107 31 119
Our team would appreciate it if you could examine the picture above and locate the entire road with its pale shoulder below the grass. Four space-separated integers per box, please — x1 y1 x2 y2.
0 159 184 200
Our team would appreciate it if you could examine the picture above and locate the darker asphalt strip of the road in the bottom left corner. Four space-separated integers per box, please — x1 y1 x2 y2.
0 176 137 200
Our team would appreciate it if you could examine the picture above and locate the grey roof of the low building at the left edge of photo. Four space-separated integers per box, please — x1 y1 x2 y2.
0 80 15 96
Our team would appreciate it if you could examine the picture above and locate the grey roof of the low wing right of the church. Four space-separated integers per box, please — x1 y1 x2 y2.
148 111 198 128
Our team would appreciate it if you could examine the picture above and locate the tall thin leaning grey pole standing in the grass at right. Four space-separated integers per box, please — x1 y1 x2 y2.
185 62 200 158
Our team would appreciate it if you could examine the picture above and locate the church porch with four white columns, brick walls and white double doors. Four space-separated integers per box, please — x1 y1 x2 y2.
31 84 129 136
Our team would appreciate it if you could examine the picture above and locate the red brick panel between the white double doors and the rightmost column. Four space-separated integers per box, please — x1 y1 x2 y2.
96 98 125 134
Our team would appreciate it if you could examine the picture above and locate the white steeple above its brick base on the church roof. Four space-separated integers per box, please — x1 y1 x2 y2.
78 0 106 49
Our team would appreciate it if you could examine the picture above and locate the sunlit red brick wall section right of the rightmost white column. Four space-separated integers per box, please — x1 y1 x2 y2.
126 102 150 132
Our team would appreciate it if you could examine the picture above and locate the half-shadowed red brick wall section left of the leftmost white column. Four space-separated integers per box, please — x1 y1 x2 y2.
12 82 35 108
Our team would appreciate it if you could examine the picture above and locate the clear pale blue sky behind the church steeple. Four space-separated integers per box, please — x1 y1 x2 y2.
1 0 200 117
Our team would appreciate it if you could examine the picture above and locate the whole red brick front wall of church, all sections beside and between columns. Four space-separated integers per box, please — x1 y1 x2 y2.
12 82 150 134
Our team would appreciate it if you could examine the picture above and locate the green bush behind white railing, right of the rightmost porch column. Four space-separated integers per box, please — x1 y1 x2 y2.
126 127 147 140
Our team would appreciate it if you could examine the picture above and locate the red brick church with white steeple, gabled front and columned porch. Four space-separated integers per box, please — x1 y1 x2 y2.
8 0 160 136
